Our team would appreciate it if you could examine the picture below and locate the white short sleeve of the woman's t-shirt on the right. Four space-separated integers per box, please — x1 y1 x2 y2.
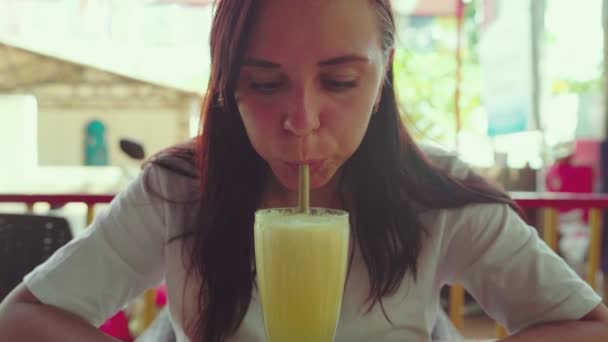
444 204 601 333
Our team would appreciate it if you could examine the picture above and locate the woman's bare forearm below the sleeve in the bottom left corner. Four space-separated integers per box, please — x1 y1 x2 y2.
0 284 117 342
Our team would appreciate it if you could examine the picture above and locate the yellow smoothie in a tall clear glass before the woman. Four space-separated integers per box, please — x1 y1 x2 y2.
255 208 350 342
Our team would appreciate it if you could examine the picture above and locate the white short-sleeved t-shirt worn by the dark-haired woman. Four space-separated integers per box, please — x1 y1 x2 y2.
25 149 601 342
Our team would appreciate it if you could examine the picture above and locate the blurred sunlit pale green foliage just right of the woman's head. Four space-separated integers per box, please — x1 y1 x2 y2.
394 14 481 143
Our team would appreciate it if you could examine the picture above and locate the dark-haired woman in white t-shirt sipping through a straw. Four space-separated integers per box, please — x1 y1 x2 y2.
0 0 608 342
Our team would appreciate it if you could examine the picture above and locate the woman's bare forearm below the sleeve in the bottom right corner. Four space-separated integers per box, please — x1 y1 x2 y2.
502 304 608 342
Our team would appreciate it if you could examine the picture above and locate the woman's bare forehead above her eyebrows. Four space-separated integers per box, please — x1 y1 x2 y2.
247 0 381 63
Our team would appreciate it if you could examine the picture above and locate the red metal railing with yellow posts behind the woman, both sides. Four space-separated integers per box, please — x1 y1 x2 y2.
0 192 608 337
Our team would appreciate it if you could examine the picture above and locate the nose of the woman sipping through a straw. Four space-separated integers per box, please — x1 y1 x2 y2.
283 85 321 137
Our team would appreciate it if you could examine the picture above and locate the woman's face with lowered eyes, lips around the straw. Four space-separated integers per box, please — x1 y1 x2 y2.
235 0 387 190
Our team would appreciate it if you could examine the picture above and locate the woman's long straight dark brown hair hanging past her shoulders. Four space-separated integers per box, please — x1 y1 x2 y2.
157 0 516 342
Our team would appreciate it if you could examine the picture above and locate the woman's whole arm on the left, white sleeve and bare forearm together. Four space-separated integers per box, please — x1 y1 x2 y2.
0 167 171 341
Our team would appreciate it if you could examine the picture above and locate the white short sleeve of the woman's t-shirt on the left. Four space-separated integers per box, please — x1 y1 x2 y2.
24 166 166 326
